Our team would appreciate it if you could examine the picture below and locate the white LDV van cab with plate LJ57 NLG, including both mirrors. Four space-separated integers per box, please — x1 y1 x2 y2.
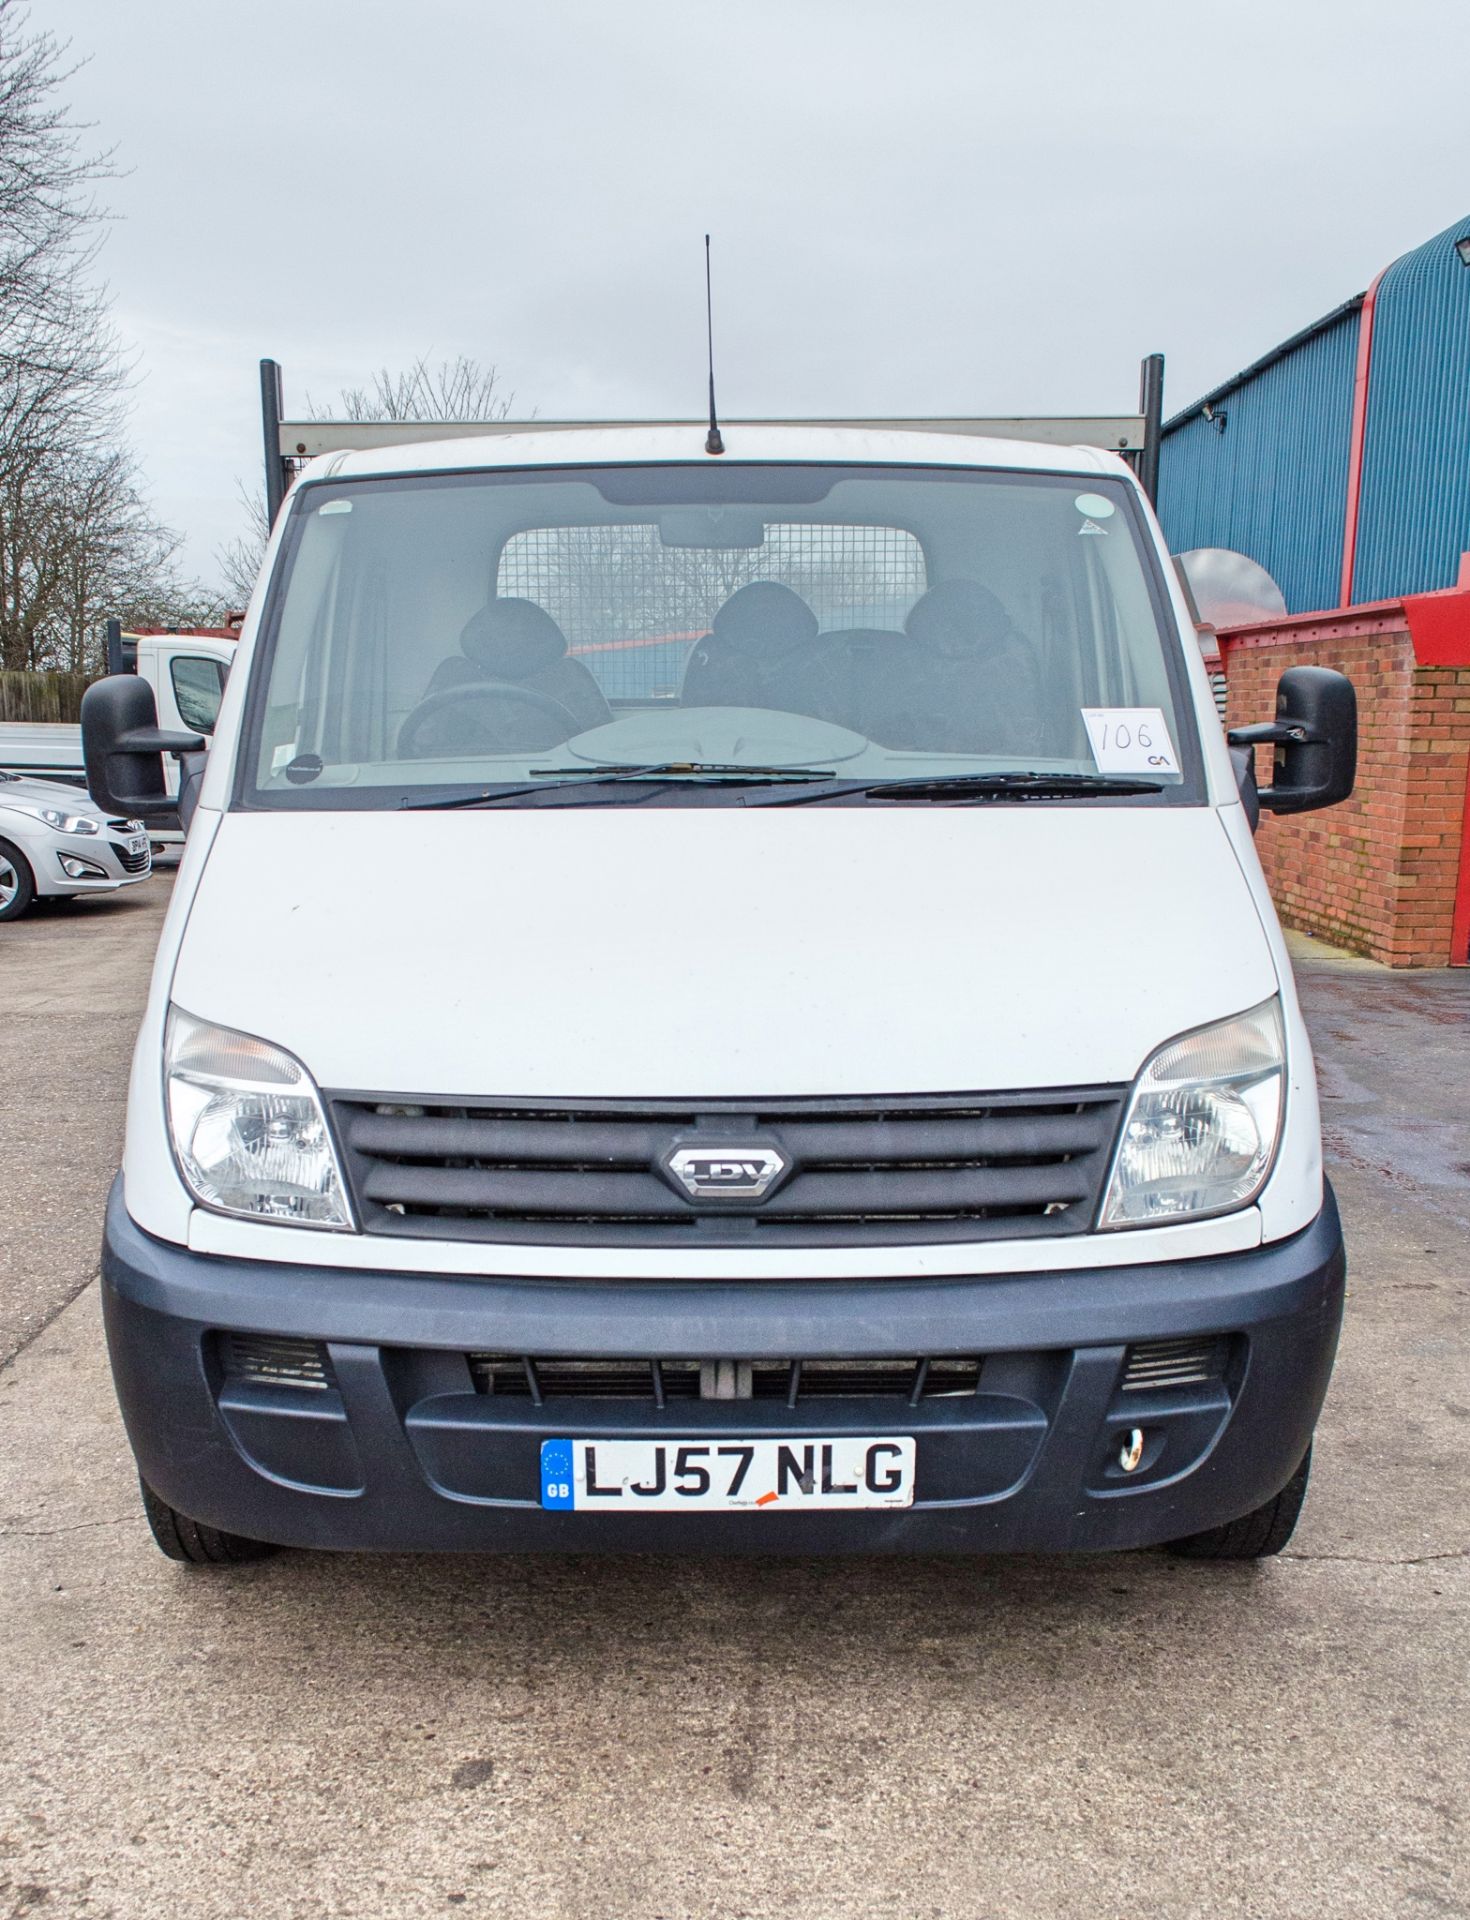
83 426 1355 1563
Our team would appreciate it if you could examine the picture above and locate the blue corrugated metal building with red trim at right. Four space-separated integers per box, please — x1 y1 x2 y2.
1159 217 1470 612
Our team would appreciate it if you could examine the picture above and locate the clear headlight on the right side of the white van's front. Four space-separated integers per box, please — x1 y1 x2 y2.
1098 998 1286 1227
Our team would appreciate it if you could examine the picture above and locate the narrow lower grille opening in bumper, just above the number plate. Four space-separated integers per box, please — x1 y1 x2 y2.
466 1354 981 1407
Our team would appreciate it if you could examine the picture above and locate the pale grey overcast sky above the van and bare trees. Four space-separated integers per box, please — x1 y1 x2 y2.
43 0 1470 578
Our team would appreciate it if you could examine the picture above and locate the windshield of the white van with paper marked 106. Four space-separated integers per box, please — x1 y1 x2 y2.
240 461 1196 808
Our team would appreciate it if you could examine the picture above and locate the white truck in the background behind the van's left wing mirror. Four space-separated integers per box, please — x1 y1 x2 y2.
0 620 238 843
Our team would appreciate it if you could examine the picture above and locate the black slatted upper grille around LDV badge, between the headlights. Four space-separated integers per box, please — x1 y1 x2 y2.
332 1087 1125 1248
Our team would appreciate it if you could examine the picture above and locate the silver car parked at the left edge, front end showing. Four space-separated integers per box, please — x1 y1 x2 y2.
0 774 154 920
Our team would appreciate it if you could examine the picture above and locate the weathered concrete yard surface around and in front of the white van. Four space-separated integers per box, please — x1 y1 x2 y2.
0 879 1470 1920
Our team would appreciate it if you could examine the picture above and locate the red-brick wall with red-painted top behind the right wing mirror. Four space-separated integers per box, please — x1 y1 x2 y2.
1221 591 1470 966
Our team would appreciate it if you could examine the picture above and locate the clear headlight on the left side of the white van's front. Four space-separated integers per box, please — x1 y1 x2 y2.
163 1006 353 1229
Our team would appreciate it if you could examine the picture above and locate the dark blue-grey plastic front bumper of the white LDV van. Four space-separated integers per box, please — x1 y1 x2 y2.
102 1179 1345 1553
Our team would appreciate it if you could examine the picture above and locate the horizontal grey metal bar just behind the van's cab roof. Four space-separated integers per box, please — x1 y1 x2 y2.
276 412 1146 465
